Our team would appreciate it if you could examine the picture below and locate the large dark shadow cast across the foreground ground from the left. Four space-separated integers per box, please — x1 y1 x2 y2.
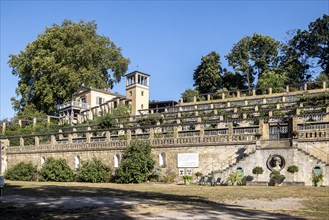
0 184 302 219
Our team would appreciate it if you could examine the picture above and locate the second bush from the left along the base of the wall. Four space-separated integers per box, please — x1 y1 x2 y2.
39 157 74 182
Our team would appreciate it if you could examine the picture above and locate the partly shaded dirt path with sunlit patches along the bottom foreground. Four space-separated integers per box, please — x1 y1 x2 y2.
0 195 302 220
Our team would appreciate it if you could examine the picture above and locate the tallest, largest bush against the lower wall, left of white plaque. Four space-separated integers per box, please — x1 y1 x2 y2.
115 141 155 183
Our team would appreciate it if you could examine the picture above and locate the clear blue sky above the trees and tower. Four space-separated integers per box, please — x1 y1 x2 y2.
0 0 329 120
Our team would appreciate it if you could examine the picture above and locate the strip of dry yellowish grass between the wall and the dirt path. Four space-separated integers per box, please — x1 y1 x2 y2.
0 181 329 219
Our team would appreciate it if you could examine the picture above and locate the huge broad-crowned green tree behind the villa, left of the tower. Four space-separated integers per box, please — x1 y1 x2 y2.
9 20 129 114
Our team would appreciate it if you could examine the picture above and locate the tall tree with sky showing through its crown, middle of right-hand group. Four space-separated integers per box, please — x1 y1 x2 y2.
226 33 280 88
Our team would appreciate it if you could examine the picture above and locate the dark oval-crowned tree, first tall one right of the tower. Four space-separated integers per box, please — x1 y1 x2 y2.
193 51 222 94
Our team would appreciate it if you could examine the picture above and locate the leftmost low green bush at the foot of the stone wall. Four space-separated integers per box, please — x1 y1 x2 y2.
5 162 37 181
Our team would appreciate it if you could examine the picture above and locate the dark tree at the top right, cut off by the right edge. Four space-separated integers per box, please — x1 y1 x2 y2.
288 14 329 77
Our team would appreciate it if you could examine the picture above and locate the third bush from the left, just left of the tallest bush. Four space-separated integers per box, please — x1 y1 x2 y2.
76 157 111 183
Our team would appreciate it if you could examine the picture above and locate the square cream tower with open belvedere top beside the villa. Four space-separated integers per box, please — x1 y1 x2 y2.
126 71 150 115
